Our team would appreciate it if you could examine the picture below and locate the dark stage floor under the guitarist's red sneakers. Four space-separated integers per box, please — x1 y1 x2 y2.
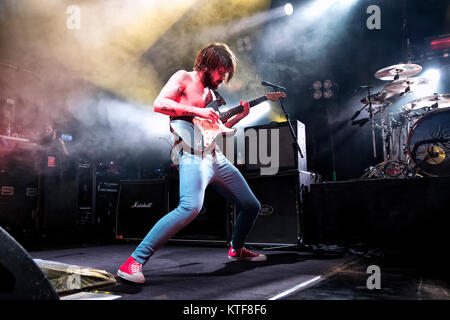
29 242 450 301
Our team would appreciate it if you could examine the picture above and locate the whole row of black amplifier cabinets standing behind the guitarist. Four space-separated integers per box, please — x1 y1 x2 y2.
116 121 321 246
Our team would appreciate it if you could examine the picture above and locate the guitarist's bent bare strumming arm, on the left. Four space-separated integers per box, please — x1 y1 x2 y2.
153 70 218 121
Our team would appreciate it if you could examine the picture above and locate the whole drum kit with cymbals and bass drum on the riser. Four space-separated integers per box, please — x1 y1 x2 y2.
351 64 450 178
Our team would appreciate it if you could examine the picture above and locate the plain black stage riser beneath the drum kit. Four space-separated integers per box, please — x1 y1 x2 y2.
303 177 450 247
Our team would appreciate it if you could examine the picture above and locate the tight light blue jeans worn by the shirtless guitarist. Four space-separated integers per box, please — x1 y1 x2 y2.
131 151 261 264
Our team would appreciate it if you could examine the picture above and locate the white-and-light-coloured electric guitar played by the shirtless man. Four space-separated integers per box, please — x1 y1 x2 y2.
170 92 286 152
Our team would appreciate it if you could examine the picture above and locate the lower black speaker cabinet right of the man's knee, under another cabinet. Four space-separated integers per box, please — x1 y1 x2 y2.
241 172 300 245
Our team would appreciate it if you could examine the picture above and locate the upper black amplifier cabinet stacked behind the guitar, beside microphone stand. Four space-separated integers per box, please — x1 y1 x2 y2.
244 120 307 172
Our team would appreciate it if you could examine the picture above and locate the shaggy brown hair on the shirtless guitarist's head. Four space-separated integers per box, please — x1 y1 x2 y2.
194 42 236 83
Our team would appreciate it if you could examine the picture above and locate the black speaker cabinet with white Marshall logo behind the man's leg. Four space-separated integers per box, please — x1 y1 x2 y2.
116 179 167 240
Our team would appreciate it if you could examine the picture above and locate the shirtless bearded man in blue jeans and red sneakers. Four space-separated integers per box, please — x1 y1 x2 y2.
117 42 266 283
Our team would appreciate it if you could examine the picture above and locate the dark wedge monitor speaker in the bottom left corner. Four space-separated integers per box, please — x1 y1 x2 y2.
0 227 59 300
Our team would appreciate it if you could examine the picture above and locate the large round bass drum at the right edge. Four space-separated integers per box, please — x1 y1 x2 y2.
407 108 450 176
